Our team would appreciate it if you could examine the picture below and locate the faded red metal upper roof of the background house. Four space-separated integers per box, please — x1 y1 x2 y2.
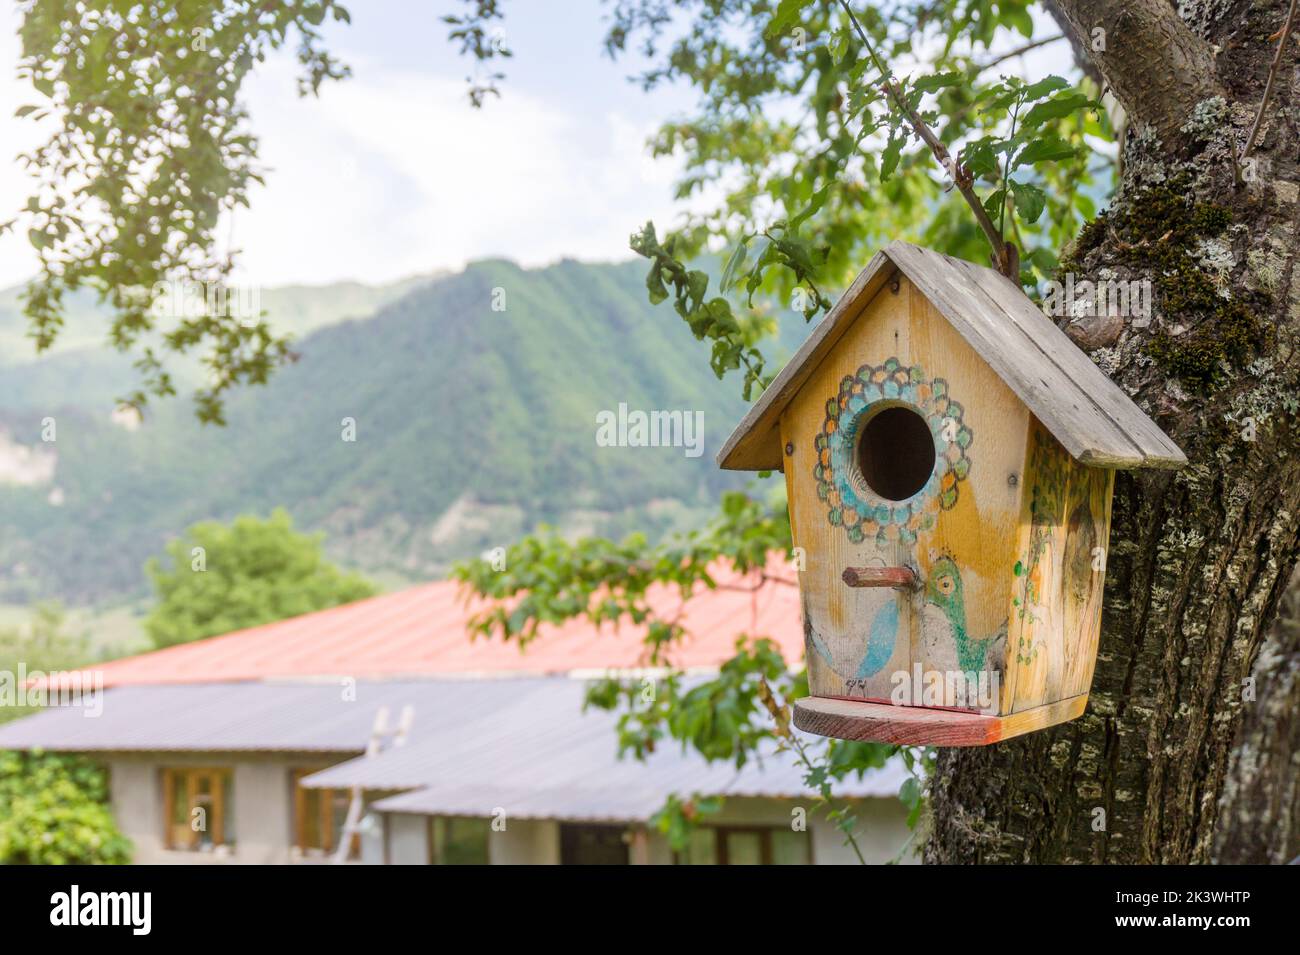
68 564 803 686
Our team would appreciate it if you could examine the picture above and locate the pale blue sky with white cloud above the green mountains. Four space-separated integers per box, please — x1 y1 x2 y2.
0 0 692 286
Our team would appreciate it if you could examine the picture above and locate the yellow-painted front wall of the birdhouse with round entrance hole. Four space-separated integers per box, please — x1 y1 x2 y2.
781 275 1030 711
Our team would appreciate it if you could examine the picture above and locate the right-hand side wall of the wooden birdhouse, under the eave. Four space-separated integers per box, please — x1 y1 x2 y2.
1004 420 1114 712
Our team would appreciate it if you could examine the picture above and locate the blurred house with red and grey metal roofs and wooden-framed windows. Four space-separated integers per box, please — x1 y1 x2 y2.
0 566 909 864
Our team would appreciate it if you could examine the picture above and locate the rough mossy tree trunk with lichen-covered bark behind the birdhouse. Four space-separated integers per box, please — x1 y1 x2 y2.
924 0 1300 863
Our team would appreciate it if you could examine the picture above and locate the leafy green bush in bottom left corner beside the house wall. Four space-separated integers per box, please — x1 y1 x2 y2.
0 751 131 865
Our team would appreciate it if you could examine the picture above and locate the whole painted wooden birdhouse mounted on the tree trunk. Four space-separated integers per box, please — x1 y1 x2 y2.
718 242 1186 746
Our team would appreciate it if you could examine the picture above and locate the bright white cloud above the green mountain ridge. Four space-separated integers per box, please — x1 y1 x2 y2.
0 8 702 285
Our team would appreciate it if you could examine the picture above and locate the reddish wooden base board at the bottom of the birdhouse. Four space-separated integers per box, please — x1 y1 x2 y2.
794 694 1088 746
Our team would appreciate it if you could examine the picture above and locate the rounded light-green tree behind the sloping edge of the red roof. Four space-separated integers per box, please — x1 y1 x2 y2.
144 509 376 647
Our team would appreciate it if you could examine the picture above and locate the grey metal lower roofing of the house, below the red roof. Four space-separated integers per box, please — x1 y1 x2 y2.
0 677 904 820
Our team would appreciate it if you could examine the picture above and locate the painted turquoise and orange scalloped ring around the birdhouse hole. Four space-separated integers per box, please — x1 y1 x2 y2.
813 357 975 543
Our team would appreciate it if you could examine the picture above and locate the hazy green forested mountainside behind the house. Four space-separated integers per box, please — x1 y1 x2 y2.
0 261 793 604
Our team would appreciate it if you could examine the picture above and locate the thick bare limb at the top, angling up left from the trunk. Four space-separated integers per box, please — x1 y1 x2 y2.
1054 0 1225 143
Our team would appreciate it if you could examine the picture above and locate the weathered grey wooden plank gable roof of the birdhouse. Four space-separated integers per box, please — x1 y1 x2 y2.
718 242 1187 470
